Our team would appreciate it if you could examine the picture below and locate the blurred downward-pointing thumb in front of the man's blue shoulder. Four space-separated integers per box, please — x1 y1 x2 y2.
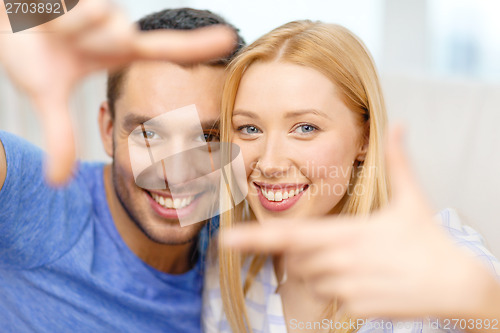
34 96 75 185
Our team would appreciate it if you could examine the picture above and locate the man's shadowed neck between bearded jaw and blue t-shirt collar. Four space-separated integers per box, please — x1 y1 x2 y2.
104 165 196 274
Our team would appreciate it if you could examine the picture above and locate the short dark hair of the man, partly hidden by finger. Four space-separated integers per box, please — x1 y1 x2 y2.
107 8 245 118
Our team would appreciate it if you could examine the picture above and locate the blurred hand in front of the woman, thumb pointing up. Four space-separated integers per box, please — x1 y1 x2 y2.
223 129 500 319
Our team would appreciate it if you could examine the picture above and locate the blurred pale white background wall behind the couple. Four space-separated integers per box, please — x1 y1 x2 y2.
0 0 500 257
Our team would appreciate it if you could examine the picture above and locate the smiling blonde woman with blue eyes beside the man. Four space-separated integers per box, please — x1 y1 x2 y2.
204 21 389 332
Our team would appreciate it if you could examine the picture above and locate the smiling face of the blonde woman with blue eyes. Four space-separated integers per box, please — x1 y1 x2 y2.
232 62 367 220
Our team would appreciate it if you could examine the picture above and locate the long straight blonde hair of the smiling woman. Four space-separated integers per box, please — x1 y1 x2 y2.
218 21 389 332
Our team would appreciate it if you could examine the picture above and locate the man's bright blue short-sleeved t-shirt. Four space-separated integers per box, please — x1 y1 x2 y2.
0 132 208 333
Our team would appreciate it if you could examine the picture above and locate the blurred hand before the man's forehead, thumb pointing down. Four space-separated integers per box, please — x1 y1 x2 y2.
0 0 235 184
